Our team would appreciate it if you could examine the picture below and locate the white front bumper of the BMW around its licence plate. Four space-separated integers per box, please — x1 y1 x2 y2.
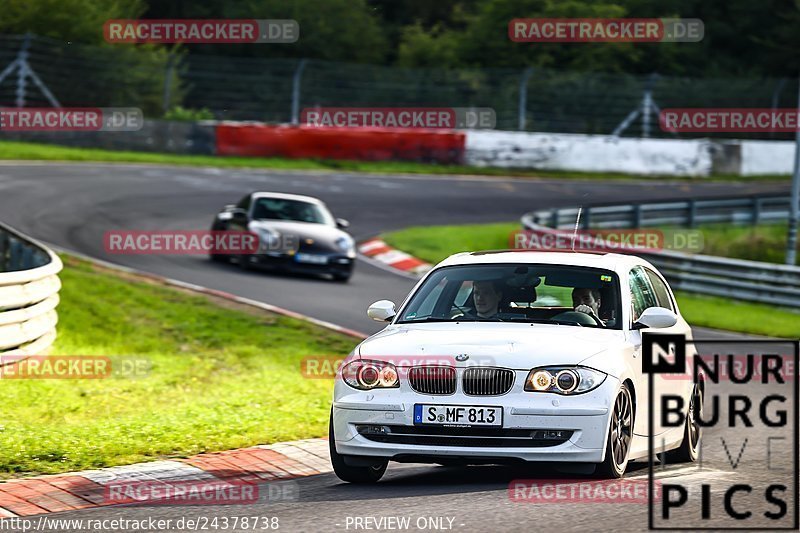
333 371 620 463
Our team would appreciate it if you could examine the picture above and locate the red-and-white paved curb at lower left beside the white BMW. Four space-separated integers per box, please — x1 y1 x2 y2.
0 438 333 519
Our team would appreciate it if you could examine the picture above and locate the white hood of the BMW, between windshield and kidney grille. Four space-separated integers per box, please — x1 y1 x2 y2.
357 322 625 370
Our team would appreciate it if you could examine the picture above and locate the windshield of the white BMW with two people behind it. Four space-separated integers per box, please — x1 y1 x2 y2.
398 264 621 329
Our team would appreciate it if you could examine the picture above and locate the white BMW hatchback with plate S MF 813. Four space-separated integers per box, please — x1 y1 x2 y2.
329 251 702 483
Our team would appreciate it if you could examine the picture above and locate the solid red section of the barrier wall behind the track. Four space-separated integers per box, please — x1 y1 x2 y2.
216 123 465 164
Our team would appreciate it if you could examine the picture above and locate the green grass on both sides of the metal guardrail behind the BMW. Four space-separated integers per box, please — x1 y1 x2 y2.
383 222 800 338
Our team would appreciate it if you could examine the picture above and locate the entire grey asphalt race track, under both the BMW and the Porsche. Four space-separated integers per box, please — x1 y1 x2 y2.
0 163 797 532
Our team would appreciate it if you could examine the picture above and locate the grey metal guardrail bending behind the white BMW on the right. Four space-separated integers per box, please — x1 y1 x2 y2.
522 196 800 310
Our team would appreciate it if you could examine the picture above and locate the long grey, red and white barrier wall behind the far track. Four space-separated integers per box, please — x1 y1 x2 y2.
0 120 794 176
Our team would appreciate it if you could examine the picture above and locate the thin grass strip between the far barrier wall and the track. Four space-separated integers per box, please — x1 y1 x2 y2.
0 141 790 181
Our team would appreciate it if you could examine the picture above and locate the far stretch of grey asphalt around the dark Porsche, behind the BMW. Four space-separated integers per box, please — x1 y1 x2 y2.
0 163 789 333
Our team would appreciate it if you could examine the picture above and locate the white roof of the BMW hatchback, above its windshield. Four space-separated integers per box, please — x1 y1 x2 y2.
436 250 654 273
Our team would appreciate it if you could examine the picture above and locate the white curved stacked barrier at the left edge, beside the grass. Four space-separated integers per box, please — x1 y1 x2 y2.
0 224 62 364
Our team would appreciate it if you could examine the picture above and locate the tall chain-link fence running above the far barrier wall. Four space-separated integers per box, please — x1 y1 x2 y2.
0 36 797 139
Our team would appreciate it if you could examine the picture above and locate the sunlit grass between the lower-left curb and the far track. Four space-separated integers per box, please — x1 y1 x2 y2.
0 258 357 478
